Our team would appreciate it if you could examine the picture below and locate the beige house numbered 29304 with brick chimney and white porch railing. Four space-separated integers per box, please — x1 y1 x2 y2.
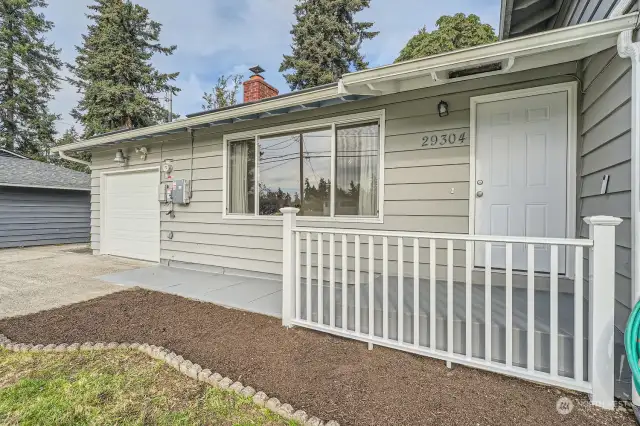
53 0 640 407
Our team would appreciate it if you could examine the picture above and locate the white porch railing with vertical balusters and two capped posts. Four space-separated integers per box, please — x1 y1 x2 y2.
281 208 621 408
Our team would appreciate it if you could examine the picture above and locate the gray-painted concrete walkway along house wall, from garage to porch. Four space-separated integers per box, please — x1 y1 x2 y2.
97 265 282 318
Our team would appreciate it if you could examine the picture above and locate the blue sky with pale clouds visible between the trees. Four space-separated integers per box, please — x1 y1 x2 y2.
45 0 500 131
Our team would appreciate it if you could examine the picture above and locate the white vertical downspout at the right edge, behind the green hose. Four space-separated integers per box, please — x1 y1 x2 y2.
610 0 640 406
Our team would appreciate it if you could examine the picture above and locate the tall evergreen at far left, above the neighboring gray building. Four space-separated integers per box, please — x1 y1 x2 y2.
0 0 62 158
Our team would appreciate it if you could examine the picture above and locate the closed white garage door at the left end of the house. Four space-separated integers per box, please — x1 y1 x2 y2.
100 170 160 262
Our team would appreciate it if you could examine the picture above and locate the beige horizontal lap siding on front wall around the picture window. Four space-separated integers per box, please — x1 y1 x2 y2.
92 63 576 276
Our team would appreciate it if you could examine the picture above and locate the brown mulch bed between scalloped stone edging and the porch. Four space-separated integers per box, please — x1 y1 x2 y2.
0 290 635 426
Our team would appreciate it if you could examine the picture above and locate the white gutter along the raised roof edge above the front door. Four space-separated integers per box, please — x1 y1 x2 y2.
342 13 638 87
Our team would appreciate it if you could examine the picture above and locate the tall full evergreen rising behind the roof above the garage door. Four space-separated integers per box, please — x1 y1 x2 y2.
68 0 180 137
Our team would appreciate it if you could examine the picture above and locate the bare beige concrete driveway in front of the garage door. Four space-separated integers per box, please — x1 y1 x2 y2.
0 244 150 318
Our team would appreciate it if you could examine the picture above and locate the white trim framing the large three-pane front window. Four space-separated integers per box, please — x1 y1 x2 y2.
222 109 386 223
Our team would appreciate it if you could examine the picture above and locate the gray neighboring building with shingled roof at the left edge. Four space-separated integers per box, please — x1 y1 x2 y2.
0 150 91 248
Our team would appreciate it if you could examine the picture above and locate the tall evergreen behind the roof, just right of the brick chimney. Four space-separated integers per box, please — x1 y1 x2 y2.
280 0 378 90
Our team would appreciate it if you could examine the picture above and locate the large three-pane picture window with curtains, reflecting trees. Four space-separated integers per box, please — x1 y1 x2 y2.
225 111 382 219
